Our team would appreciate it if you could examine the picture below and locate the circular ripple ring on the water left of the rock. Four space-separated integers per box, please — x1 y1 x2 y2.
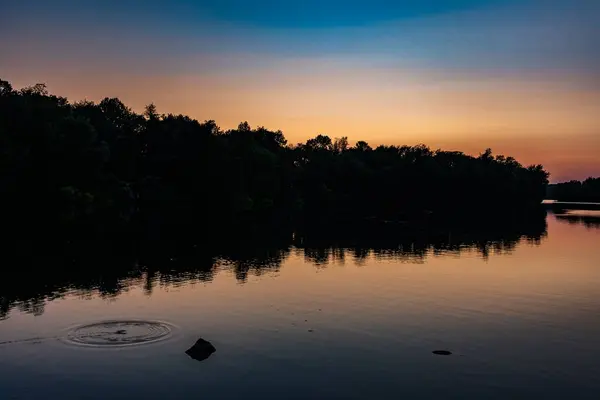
63 320 173 347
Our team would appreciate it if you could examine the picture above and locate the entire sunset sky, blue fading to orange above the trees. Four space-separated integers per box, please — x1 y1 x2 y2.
0 0 600 182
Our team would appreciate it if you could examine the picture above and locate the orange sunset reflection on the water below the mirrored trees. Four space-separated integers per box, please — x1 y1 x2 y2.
25 215 600 329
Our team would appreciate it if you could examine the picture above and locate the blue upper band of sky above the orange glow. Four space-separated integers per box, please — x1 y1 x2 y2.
0 0 600 71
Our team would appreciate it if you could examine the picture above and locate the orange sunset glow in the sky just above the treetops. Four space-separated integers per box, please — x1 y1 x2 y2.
5 65 600 181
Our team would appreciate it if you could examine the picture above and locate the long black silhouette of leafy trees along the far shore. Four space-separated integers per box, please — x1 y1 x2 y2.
0 80 549 244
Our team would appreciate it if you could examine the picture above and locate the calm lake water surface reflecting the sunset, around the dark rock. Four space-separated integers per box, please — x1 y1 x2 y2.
0 211 600 400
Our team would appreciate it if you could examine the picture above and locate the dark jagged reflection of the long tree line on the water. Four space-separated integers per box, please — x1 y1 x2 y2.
0 218 548 318
